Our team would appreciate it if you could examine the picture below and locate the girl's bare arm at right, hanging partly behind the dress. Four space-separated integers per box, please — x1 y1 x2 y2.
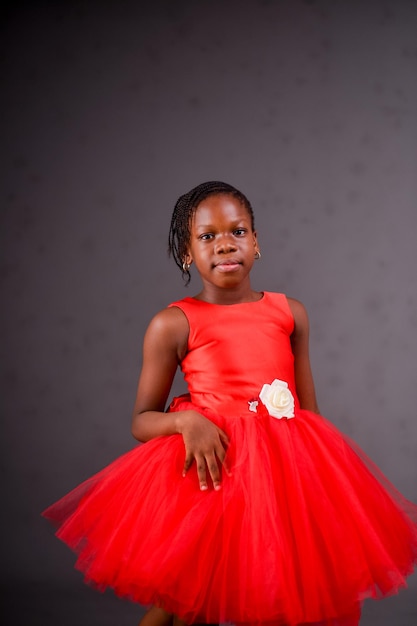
288 298 320 413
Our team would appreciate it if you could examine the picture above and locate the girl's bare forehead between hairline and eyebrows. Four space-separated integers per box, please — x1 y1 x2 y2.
192 194 250 227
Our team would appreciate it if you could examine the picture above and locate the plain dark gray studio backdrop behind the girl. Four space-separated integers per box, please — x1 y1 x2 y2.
1 0 417 626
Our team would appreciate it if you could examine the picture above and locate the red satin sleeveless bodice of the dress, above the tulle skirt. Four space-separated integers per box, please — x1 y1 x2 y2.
170 292 298 415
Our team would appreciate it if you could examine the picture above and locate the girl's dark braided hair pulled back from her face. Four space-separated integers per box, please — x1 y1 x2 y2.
168 181 255 285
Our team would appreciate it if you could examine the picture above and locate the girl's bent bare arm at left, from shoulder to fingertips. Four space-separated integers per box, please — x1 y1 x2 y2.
132 307 228 490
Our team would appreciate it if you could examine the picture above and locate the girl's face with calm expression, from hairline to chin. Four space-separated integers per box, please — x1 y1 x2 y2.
185 194 258 289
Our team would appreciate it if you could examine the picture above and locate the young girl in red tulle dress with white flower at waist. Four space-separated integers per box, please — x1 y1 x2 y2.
44 182 417 626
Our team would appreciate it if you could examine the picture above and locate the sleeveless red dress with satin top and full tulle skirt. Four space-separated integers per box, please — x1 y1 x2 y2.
44 293 417 626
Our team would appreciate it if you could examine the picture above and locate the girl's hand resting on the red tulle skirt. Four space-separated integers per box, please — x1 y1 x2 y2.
180 411 230 491
